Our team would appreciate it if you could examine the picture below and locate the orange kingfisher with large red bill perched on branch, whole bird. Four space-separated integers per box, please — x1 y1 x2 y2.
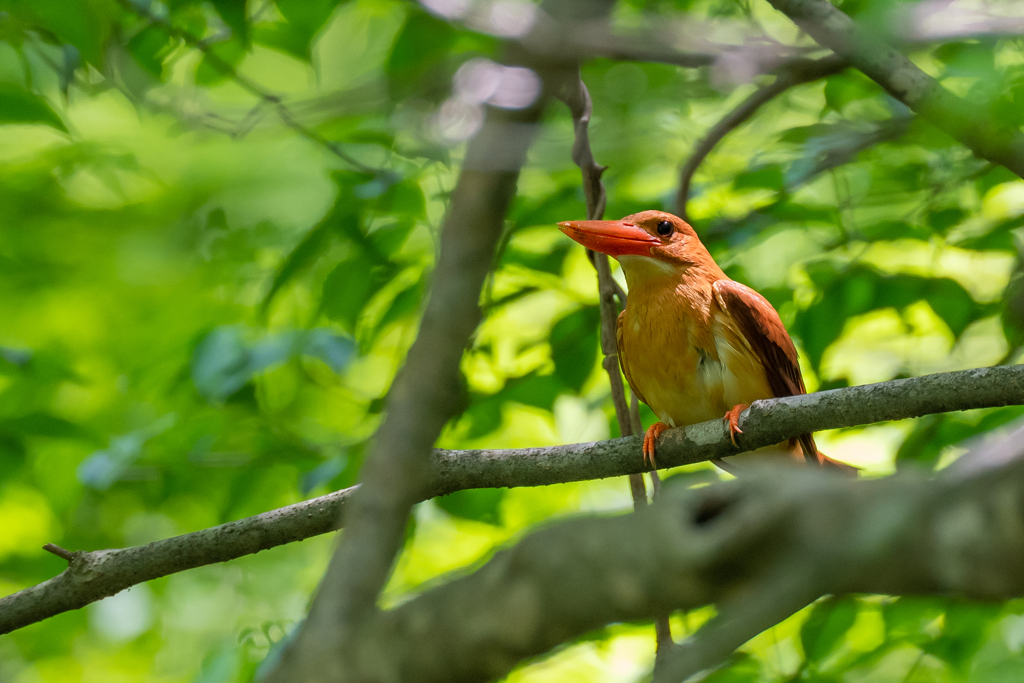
558 211 856 472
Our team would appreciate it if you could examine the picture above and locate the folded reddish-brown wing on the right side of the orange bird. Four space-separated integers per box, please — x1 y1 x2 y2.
712 280 824 464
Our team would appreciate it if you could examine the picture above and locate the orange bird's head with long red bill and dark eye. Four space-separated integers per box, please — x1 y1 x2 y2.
558 211 717 278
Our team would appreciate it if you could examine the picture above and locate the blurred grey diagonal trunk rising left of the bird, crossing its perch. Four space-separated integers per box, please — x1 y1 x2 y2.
260 96 546 682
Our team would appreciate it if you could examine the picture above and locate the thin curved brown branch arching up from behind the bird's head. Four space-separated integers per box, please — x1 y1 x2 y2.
676 54 847 220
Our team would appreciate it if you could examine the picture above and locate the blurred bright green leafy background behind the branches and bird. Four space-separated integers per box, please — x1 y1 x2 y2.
0 0 1024 683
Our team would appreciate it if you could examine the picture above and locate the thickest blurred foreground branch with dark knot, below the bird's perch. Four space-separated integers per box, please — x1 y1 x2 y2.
319 448 1024 683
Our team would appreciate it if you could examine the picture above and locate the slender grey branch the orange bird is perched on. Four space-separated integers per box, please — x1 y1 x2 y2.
6 366 1024 634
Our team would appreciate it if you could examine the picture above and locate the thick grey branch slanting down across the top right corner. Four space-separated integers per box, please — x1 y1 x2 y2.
768 0 1024 177
